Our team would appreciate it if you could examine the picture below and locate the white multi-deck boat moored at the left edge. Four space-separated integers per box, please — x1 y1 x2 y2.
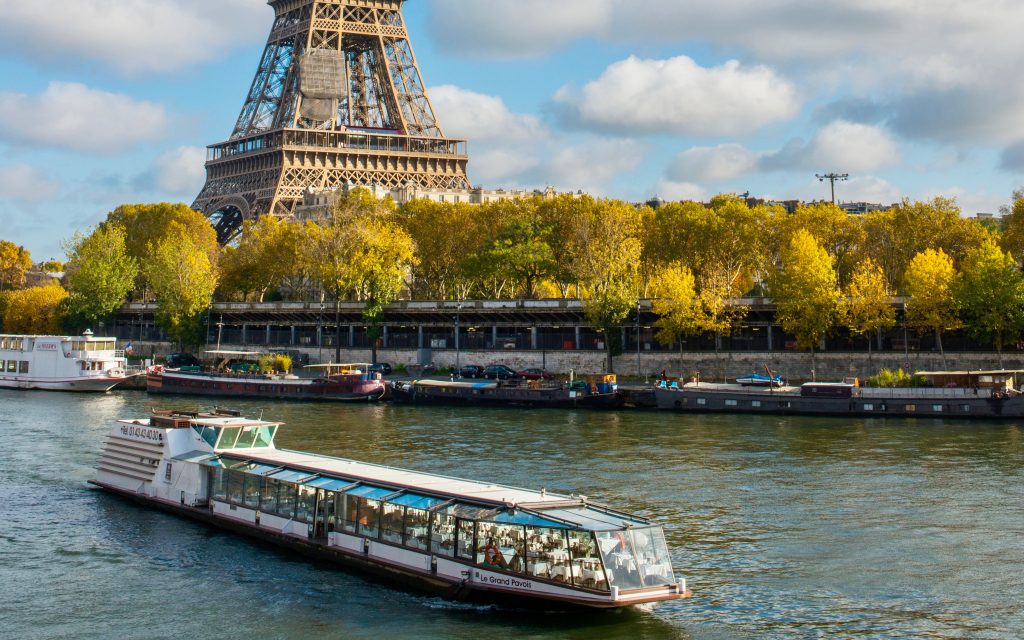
0 331 132 392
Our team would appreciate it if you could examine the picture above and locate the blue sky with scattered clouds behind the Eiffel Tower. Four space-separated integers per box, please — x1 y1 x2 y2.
0 0 1024 260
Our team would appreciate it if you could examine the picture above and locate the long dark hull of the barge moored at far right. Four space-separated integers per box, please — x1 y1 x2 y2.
654 387 1024 420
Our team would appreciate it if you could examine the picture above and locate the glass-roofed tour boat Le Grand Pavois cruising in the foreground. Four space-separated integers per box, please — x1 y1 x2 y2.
91 411 689 609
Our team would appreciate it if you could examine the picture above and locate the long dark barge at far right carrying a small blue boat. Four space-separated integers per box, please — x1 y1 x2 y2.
654 371 1024 420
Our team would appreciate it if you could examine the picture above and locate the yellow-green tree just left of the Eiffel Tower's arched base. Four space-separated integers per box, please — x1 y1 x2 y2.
142 223 218 345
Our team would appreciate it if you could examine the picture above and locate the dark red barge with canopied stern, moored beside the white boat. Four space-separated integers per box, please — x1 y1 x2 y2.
146 352 387 401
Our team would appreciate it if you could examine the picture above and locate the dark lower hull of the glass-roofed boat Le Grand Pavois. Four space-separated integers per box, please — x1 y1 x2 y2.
90 480 690 610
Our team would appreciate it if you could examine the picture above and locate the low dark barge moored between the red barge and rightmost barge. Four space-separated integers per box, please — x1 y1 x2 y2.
391 375 623 409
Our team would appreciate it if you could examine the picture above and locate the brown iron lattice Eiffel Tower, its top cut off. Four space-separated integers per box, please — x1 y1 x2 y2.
193 0 470 243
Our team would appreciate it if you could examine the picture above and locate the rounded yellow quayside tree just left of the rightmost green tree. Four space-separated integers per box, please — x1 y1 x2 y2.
903 249 961 362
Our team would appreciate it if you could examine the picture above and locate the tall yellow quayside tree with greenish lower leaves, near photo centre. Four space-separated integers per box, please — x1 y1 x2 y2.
570 199 643 373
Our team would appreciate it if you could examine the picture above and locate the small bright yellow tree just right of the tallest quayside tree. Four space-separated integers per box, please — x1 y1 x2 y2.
652 262 708 373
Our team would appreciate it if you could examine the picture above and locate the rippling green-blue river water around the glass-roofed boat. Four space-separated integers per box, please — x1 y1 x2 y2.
0 392 1024 640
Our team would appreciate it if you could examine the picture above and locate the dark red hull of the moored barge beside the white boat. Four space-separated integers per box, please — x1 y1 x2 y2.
146 372 387 402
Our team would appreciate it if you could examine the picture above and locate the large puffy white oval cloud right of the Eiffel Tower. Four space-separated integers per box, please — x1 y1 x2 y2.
554 55 800 136
